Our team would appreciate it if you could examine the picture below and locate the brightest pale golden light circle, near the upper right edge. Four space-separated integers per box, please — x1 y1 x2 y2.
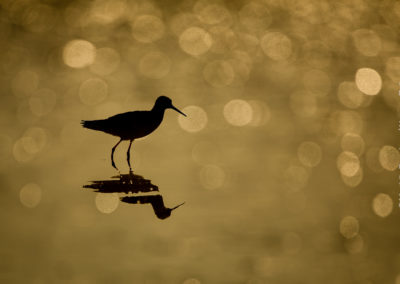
355 68 382 96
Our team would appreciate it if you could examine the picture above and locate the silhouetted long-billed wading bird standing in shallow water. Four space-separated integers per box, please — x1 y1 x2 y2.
81 96 186 172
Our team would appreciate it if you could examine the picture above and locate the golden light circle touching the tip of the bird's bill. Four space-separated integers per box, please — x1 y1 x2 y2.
178 106 208 132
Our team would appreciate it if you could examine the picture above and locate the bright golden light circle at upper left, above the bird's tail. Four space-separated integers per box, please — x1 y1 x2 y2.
63 39 96 68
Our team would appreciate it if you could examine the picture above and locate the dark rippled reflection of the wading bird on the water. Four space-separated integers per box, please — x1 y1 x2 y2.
83 171 184 219
